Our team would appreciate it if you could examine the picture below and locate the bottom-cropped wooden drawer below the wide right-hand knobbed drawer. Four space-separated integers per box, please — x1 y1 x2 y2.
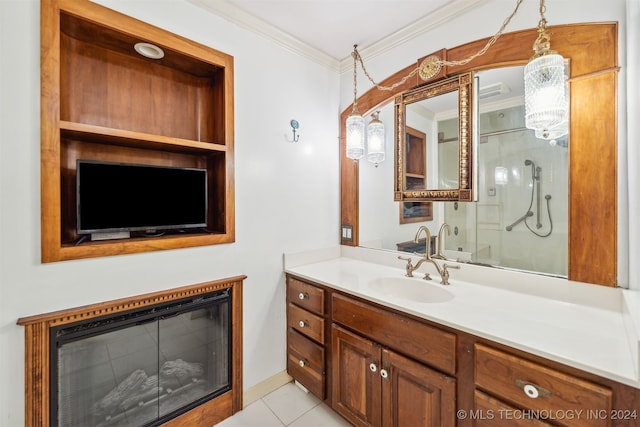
473 390 552 427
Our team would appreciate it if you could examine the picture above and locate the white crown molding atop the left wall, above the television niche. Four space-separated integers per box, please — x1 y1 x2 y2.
187 0 340 71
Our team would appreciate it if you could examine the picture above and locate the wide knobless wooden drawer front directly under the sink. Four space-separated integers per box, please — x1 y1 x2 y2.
331 294 456 375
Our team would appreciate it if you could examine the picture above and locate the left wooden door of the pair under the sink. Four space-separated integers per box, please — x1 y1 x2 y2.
331 325 381 426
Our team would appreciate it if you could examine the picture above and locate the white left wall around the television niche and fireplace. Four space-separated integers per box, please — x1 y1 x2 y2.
0 0 340 427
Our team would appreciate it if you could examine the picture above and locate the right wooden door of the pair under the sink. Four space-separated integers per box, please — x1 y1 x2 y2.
381 349 456 427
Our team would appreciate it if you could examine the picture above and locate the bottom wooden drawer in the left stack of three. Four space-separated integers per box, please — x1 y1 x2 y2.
287 328 325 400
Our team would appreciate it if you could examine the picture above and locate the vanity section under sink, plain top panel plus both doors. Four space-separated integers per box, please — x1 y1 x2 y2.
331 293 456 427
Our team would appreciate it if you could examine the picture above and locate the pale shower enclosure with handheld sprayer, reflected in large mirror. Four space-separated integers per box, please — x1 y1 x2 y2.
440 105 569 277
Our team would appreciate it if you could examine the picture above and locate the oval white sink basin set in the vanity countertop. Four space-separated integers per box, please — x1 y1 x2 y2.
368 277 453 303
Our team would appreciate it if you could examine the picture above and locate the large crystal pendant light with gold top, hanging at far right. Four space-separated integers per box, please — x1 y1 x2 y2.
524 0 569 132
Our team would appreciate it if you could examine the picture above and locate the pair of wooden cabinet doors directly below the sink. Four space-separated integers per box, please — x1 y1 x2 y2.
331 324 456 427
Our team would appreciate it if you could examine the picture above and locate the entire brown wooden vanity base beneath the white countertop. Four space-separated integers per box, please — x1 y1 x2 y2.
287 275 640 427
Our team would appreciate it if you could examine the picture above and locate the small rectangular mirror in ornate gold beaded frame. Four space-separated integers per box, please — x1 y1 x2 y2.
394 73 476 201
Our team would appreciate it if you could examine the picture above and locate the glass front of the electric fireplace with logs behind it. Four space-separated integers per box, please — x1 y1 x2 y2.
52 290 231 427
